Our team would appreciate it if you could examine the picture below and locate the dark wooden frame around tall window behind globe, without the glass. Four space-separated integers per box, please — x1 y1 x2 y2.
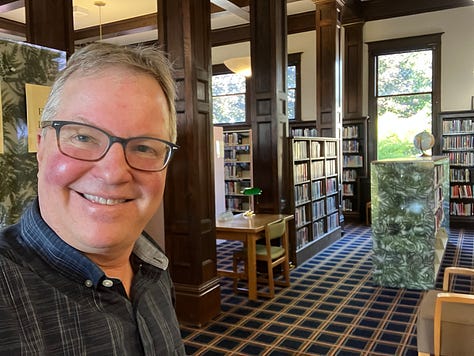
367 33 443 162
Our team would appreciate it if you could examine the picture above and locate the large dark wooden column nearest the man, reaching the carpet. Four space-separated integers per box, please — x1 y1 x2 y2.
158 0 220 326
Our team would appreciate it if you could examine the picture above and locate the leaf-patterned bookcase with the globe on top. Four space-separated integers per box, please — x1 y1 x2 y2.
371 156 449 289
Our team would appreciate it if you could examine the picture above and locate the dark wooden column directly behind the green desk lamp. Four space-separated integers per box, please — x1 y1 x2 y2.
250 0 289 213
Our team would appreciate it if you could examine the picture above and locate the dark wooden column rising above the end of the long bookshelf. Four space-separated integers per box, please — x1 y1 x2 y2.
313 0 344 137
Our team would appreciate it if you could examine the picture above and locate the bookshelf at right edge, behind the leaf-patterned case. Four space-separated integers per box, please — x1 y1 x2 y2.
439 111 474 226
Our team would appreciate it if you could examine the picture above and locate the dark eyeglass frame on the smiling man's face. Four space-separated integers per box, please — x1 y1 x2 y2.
40 120 179 172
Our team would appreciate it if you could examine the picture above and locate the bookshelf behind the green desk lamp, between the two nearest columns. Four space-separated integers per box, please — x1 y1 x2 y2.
224 130 253 213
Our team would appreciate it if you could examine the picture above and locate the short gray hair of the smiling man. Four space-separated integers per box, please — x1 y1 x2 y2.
41 43 177 143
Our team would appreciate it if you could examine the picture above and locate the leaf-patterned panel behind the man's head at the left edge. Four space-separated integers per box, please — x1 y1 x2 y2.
0 39 66 227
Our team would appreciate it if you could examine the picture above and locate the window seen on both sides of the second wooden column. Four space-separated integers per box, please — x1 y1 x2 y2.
212 53 301 124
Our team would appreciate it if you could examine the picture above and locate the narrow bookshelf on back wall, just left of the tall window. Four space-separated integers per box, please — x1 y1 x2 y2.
342 117 367 220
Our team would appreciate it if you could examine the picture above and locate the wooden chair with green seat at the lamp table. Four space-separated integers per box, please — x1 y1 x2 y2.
233 219 290 298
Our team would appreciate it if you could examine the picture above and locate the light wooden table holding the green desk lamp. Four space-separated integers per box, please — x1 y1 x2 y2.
216 214 293 300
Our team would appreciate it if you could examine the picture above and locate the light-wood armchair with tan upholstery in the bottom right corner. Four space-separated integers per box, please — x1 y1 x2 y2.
417 267 474 356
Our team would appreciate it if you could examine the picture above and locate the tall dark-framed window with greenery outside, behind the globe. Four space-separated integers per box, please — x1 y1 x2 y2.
369 35 441 160
